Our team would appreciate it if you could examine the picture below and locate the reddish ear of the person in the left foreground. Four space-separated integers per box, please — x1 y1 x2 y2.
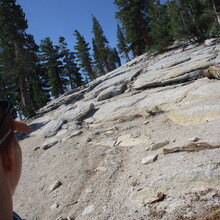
2 141 14 172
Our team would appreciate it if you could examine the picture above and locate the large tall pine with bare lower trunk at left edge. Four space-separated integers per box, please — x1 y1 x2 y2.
0 0 34 116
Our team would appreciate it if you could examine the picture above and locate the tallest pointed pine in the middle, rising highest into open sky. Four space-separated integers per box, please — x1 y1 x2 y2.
92 16 114 74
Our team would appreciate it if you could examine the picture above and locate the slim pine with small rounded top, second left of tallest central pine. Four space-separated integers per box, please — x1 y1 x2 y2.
59 37 82 89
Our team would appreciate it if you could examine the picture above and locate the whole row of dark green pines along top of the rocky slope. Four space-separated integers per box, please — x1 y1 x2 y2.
0 0 220 116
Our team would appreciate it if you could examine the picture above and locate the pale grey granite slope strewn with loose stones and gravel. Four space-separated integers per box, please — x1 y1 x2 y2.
14 40 220 220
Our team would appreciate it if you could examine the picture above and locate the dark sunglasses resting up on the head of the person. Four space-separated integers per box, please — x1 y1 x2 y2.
0 100 17 145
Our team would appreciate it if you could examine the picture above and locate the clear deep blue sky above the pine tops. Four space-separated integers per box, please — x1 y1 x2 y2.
17 0 167 50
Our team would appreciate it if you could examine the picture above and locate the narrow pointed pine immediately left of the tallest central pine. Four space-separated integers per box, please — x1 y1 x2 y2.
74 30 96 80
